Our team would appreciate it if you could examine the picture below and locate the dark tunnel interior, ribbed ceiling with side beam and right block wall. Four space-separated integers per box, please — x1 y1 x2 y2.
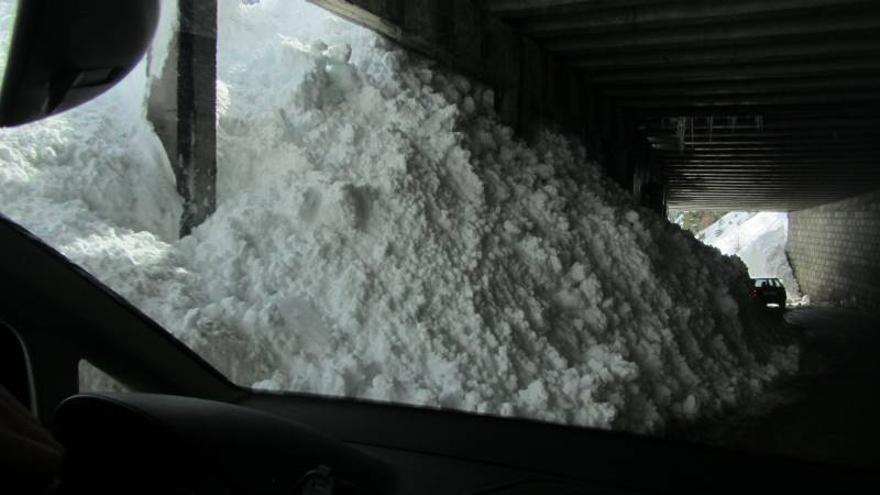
311 0 880 308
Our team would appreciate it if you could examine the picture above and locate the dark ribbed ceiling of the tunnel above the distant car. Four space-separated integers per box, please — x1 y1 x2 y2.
480 0 880 210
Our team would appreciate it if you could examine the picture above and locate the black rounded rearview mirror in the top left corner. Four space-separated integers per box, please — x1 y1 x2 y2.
0 0 159 127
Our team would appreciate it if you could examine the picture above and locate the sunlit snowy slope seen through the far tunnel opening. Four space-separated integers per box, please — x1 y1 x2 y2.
697 211 801 301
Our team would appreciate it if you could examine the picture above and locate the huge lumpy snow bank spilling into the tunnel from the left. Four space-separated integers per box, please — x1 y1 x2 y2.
0 0 796 431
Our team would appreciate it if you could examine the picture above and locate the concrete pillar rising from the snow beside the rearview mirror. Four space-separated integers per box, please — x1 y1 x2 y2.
148 0 217 240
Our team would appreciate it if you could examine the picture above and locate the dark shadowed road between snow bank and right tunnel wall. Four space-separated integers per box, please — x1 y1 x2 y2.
671 308 880 470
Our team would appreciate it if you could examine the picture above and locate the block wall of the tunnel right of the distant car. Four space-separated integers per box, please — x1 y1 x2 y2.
786 190 880 309
